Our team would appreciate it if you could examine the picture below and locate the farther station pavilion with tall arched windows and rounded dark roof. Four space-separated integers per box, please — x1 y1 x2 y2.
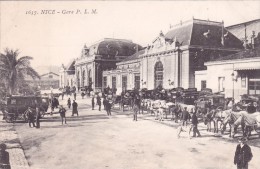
75 38 141 91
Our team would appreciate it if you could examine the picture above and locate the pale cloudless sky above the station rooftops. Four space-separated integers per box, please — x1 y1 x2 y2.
0 1 260 67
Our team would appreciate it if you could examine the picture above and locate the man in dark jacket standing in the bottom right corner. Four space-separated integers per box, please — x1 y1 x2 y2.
234 137 253 169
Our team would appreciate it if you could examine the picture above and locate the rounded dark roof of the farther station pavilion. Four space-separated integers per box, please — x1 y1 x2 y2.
84 38 142 58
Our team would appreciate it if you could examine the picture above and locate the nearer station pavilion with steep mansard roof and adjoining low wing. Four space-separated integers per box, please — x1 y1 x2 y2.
103 19 243 93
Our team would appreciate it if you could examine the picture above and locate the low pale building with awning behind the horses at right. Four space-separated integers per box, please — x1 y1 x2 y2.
195 47 260 100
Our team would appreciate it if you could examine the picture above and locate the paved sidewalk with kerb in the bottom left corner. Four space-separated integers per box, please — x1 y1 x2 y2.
0 114 30 169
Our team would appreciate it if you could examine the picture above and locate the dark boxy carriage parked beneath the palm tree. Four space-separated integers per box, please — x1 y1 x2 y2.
2 96 49 122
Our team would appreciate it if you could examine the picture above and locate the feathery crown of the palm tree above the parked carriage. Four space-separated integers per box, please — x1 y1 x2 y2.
0 48 40 95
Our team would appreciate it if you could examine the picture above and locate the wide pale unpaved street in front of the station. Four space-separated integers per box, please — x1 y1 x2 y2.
3 97 260 169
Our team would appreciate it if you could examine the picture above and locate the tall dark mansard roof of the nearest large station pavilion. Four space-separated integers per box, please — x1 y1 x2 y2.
165 19 243 49
